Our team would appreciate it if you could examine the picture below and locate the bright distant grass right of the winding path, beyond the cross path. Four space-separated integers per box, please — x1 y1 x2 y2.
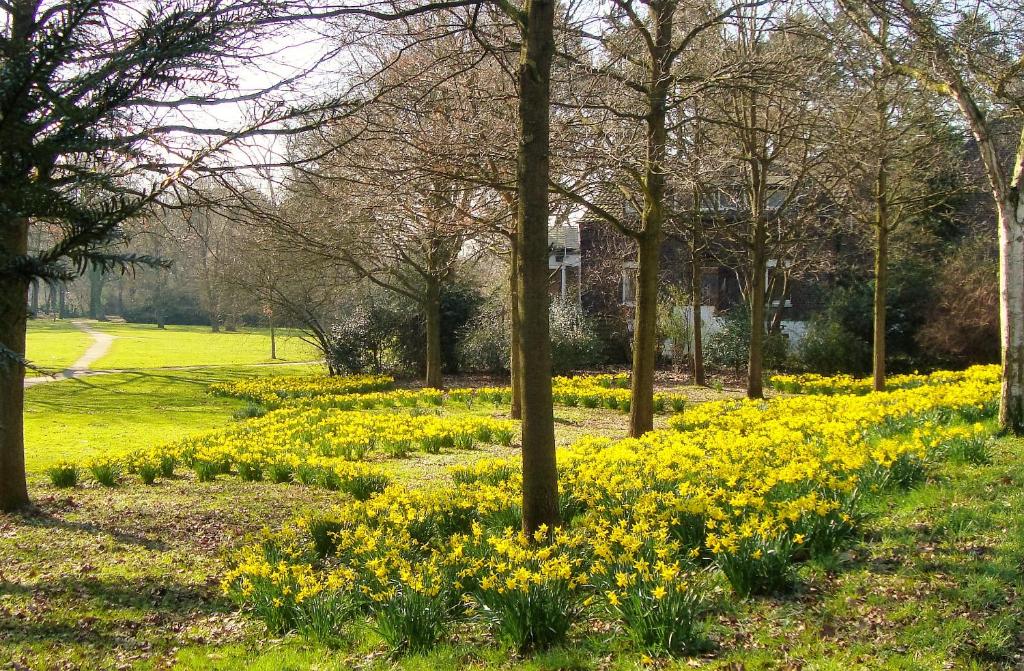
92 323 319 370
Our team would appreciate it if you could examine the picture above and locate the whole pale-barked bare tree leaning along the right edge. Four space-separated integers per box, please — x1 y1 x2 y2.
839 0 1024 434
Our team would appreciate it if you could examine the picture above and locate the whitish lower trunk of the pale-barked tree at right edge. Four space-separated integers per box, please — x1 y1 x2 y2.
998 194 1024 435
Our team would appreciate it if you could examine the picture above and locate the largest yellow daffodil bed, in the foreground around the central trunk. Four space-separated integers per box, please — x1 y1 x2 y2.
223 368 998 655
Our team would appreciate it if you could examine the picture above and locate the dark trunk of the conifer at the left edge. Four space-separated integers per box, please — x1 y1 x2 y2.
0 220 29 511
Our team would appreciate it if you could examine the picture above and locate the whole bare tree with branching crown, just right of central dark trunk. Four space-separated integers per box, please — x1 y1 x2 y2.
558 0 757 436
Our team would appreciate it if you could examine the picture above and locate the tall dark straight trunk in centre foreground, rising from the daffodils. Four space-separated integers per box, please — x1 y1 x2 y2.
516 0 561 536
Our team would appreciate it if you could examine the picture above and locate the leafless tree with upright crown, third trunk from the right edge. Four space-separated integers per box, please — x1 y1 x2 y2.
712 2 830 399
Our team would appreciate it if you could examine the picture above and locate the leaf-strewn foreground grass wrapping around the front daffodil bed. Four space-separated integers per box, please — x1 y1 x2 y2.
0 411 1024 671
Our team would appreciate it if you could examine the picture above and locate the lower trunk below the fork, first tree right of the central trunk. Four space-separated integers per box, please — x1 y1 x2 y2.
630 233 662 437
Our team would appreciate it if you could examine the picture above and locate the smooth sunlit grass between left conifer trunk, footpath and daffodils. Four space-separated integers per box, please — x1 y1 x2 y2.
25 366 316 473
